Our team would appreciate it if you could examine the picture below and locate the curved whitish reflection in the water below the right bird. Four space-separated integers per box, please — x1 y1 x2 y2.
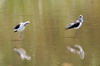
67 45 85 59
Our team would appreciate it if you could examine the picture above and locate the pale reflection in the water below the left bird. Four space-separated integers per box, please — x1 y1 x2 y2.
14 48 31 60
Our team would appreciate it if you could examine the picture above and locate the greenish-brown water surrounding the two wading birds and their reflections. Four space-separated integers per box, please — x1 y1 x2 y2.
0 0 100 66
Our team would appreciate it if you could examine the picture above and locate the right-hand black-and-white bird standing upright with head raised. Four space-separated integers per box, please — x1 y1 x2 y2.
65 15 83 30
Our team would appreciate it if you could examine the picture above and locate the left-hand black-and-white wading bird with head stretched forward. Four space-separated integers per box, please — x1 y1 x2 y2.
13 21 30 38
